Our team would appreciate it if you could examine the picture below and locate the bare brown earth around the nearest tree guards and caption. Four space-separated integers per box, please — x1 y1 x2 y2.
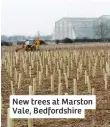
1 43 110 127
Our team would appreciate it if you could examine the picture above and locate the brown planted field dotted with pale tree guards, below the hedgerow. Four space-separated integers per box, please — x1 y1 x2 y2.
1 43 110 127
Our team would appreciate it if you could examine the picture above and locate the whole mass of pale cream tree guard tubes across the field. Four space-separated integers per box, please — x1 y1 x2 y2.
2 49 110 127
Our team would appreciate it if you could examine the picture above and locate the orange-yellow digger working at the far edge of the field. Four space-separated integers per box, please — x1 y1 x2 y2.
16 37 40 52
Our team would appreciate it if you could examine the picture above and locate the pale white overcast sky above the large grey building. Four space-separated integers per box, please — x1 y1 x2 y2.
1 0 110 36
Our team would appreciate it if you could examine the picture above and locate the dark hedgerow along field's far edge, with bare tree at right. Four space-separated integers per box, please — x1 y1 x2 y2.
1 20 110 46
